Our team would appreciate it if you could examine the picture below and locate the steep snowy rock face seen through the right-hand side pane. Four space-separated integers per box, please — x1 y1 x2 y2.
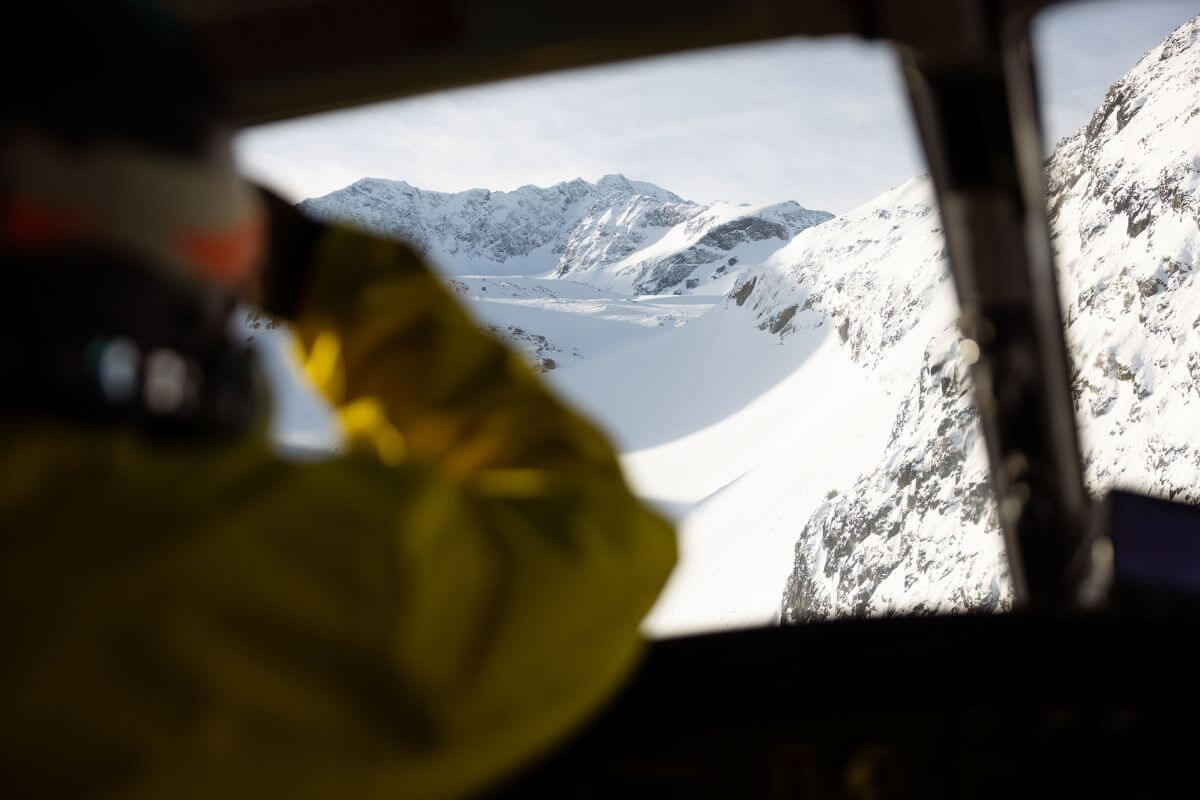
1048 18 1200 501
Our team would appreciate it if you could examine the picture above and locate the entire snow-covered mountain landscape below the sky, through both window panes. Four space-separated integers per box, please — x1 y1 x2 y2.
265 14 1200 633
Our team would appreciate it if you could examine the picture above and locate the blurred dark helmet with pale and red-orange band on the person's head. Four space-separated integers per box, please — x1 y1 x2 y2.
0 0 265 433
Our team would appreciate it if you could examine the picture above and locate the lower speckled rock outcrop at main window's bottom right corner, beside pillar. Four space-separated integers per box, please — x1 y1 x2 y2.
781 327 1009 622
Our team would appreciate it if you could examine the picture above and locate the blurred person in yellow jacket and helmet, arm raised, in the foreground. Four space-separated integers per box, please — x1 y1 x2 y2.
0 2 674 798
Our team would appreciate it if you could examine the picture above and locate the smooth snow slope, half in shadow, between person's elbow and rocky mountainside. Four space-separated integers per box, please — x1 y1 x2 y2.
552 306 888 633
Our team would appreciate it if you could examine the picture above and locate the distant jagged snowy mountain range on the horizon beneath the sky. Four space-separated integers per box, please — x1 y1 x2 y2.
300 175 832 295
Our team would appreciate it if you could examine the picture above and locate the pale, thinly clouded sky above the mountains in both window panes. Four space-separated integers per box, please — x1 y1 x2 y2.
236 0 1200 213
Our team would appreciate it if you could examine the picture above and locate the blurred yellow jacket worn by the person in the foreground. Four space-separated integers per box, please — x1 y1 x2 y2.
0 229 674 798
